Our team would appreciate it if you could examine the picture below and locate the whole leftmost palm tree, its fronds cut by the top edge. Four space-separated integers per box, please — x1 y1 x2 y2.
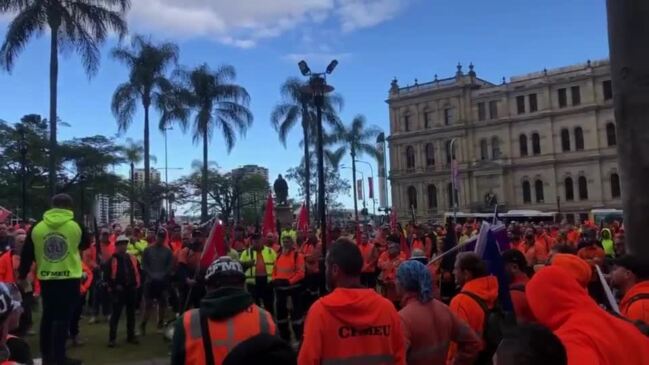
0 0 131 195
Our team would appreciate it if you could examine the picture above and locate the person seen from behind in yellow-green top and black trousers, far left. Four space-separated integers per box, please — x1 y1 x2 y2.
18 194 90 364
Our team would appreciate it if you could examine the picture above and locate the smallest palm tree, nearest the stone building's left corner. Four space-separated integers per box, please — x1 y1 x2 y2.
333 114 381 221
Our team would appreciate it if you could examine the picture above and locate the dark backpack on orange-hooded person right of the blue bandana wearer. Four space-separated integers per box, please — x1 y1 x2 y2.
460 291 508 365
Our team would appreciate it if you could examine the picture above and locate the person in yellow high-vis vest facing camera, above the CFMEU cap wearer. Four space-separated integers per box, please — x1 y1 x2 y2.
240 233 277 312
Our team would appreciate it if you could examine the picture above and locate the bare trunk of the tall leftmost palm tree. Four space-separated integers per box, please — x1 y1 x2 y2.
48 24 59 196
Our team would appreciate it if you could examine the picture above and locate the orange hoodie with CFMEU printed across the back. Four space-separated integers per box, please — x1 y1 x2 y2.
298 288 406 365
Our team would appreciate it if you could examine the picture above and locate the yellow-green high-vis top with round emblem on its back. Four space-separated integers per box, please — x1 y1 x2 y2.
32 209 83 280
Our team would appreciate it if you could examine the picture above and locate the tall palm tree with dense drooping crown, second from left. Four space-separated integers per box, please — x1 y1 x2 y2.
111 36 184 223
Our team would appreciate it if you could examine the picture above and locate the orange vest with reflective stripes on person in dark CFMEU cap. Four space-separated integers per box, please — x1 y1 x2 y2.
183 304 276 365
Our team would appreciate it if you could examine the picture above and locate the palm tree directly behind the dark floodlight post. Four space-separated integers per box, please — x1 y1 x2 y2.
270 77 344 222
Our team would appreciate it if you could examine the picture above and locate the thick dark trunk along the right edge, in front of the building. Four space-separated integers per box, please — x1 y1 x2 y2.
607 0 649 259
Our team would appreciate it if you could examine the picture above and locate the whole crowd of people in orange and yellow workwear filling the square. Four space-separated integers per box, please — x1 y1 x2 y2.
0 194 649 365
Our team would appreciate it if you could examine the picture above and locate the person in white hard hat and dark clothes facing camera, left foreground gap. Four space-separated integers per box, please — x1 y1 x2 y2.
104 236 140 347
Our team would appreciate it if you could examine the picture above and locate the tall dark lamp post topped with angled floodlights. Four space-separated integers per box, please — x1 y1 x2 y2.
298 60 338 262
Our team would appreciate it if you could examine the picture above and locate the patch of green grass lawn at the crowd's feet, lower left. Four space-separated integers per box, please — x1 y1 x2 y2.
27 312 170 365
